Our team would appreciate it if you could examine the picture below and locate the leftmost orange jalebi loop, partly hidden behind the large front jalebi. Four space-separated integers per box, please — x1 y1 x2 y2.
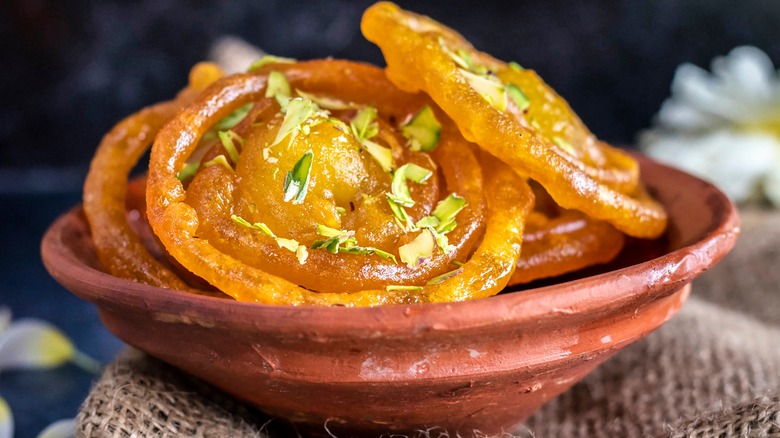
83 63 222 289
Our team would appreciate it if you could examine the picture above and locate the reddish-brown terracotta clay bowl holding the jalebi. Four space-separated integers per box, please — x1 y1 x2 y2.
42 154 739 436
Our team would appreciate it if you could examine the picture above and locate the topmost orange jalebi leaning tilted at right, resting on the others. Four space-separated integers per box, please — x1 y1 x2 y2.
361 3 667 238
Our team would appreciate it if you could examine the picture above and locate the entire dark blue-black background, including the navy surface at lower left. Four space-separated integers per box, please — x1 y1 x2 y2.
0 0 780 437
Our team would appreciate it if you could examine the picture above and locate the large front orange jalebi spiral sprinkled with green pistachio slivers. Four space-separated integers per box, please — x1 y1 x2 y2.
147 60 533 306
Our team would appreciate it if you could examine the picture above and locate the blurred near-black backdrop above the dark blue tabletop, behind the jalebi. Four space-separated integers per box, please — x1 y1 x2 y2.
0 0 780 176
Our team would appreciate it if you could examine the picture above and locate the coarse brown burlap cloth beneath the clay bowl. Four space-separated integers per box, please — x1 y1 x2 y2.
77 211 780 437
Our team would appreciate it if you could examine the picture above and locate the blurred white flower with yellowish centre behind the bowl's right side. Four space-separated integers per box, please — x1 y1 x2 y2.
639 47 780 207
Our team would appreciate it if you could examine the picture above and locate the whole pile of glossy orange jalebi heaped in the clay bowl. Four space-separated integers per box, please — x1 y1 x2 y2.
84 3 666 306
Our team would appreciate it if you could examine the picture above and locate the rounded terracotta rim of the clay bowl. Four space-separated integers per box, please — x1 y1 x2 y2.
41 154 739 336
